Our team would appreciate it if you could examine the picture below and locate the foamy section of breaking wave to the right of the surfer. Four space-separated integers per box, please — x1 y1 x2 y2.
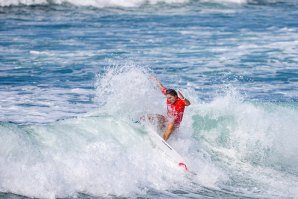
195 91 298 197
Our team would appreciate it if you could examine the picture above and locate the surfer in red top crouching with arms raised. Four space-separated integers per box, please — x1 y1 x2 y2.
149 76 190 141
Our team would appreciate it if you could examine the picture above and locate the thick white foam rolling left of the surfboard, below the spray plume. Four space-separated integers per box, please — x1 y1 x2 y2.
0 117 198 198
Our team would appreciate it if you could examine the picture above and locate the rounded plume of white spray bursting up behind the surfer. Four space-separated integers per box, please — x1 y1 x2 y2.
96 62 165 118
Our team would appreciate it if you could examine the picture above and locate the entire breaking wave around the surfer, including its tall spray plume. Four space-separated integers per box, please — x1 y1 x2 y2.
0 67 298 198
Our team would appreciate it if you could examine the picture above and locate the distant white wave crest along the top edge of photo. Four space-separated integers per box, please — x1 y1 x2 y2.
0 0 295 8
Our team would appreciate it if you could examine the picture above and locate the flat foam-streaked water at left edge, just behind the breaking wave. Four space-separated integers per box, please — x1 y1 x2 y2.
0 86 96 123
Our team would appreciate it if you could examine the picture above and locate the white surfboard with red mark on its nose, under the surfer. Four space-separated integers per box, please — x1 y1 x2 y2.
148 129 188 171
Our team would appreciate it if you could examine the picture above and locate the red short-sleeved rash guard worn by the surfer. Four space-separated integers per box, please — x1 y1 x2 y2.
162 88 186 128
